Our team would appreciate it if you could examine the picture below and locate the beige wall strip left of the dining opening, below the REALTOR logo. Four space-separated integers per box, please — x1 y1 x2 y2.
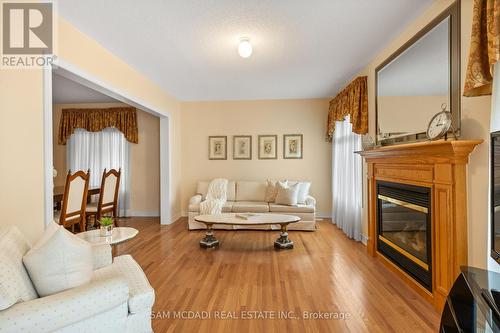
0 69 44 240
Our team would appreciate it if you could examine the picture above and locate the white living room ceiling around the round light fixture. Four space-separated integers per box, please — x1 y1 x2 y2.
57 0 432 101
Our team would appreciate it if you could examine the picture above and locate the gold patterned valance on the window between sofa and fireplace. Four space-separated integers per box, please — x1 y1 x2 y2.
326 76 368 142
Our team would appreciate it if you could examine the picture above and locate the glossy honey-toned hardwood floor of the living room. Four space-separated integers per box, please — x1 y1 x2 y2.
116 218 439 333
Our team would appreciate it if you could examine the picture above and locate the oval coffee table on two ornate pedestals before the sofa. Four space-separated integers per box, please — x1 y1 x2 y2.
194 213 300 249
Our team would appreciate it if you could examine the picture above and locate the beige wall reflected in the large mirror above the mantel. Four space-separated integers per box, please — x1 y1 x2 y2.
378 96 449 133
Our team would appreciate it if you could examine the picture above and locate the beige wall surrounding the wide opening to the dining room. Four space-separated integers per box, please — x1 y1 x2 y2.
0 8 181 241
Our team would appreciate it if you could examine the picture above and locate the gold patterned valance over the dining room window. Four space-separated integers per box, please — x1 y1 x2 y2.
59 107 139 145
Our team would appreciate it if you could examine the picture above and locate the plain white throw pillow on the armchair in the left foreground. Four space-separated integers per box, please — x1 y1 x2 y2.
23 226 93 297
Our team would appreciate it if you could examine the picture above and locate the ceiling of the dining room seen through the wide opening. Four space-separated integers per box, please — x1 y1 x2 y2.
52 74 118 104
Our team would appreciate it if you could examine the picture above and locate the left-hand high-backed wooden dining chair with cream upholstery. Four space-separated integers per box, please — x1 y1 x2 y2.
54 170 90 232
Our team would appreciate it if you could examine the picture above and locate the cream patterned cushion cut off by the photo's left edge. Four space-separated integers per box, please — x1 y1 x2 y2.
0 226 38 310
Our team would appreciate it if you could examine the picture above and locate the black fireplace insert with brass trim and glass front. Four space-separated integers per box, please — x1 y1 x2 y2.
377 181 432 292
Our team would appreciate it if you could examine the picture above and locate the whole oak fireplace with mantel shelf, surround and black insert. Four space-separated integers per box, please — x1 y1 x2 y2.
359 140 482 313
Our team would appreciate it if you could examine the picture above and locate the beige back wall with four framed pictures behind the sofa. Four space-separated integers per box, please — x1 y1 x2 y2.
181 99 331 214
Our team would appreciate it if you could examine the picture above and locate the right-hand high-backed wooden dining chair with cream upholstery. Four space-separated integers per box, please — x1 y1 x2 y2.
86 169 122 226
